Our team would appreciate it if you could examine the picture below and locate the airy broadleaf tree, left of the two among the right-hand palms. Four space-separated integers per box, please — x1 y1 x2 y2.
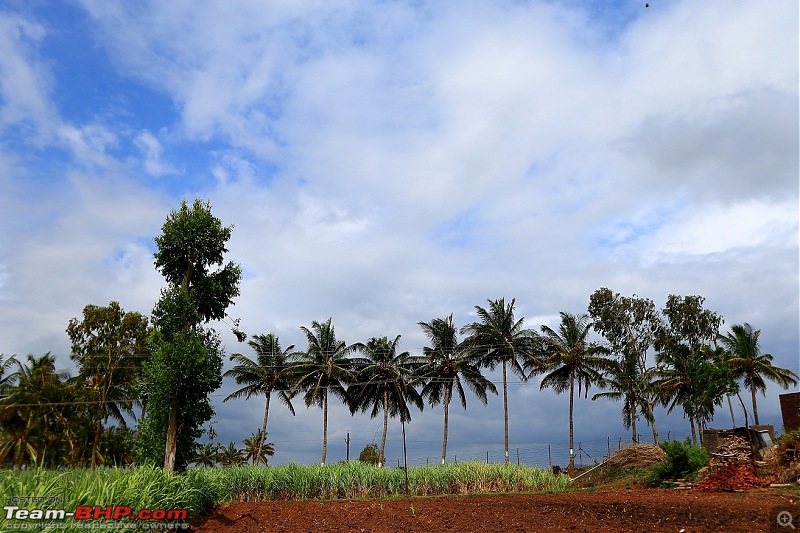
589 287 663 444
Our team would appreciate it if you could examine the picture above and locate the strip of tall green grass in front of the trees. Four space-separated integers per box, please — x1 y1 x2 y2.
0 462 569 531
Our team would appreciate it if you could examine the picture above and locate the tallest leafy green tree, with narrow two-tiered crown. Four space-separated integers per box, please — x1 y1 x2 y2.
141 199 241 471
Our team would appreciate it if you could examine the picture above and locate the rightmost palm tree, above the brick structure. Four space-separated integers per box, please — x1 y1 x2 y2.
717 322 800 425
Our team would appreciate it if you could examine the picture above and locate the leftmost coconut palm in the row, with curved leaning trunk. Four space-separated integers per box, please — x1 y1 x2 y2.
223 333 295 465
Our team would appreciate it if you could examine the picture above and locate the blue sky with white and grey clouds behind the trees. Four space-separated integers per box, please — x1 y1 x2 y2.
0 0 800 466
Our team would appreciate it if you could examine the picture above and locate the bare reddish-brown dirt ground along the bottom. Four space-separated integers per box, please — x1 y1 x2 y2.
193 484 800 533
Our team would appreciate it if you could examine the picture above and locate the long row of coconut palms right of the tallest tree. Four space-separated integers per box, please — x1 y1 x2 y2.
225 298 798 467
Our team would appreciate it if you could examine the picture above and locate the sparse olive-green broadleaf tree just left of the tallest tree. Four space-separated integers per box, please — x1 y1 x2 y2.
67 301 148 468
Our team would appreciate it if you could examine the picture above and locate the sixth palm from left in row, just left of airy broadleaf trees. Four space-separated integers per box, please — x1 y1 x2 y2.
526 312 608 469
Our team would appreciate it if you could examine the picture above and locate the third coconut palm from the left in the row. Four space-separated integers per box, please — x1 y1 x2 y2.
348 335 424 466
